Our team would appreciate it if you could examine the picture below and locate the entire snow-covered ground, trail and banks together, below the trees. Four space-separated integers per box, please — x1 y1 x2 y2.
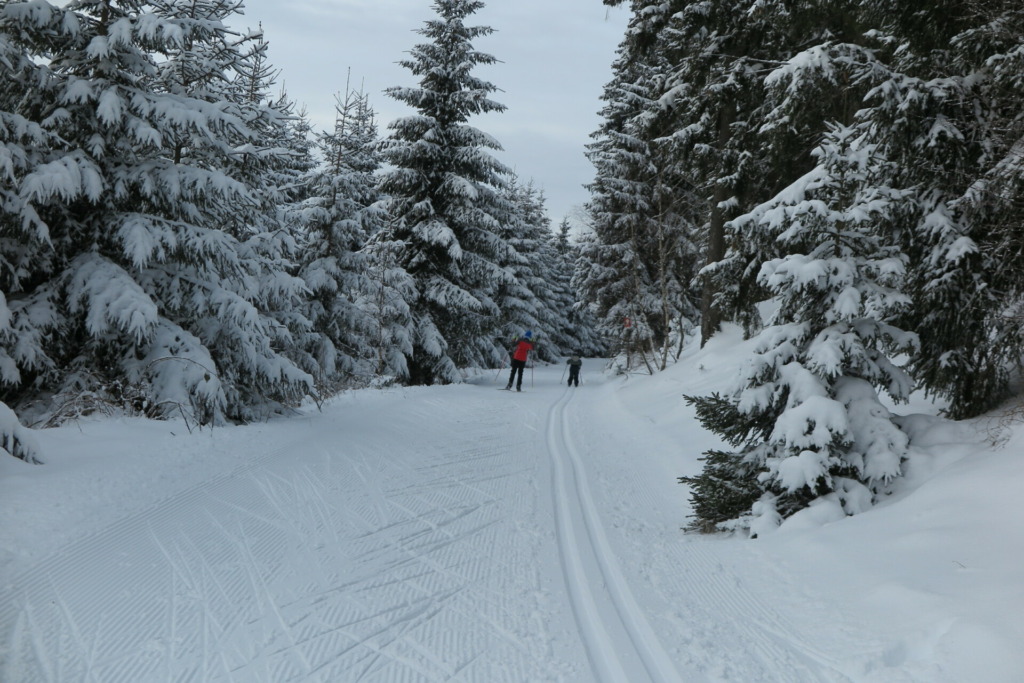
0 335 1024 683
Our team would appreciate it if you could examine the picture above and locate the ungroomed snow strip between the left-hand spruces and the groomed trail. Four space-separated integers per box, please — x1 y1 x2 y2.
0 391 403 578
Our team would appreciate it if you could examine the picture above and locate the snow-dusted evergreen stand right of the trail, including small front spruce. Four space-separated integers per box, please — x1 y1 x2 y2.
582 0 1024 529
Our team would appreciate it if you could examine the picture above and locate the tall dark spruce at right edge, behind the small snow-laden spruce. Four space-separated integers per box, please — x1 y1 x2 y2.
865 0 1024 418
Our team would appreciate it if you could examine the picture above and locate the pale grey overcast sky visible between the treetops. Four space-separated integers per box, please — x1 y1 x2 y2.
239 0 629 225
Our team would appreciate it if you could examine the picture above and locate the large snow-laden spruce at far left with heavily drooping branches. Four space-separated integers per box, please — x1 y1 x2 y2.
0 0 310 421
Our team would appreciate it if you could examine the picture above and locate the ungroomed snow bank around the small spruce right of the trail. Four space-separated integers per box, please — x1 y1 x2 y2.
585 327 1024 683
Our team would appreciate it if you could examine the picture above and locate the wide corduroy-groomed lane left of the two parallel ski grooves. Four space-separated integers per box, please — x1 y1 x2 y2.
0 401 564 683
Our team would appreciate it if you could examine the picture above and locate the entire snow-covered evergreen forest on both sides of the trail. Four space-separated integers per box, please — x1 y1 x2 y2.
0 0 1024 535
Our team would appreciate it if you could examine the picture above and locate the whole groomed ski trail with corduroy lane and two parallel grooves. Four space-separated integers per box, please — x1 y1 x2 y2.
0 369 857 683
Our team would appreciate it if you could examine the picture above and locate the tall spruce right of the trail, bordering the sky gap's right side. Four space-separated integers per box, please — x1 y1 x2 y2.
583 2 698 371
